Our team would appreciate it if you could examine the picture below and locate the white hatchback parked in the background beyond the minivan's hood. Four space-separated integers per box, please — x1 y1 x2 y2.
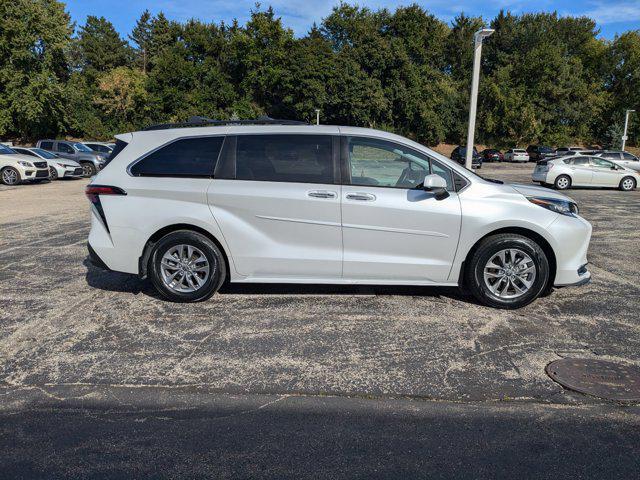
531 155 640 191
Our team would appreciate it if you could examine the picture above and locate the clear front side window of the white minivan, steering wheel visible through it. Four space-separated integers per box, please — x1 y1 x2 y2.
348 137 453 190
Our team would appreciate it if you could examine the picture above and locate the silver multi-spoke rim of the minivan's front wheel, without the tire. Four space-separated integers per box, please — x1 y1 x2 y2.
484 248 537 299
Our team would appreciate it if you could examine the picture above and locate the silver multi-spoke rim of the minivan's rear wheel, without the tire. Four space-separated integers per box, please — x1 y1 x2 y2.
160 244 211 293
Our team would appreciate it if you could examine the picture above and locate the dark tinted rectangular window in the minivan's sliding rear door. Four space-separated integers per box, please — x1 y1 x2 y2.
236 135 334 183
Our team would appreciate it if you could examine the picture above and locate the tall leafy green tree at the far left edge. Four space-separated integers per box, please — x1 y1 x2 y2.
0 0 72 138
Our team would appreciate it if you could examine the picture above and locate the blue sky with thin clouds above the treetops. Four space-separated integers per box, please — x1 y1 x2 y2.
65 0 640 39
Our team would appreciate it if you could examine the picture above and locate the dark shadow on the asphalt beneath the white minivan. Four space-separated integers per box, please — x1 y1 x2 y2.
83 256 478 305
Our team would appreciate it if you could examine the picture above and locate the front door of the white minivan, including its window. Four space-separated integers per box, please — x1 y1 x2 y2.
342 137 461 284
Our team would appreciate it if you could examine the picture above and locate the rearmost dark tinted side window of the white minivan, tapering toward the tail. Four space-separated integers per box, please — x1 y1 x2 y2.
129 137 224 177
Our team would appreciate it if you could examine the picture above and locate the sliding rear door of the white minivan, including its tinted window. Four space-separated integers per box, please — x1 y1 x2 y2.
208 130 342 281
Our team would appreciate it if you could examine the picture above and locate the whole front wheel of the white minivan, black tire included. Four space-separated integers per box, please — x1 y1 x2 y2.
465 233 549 309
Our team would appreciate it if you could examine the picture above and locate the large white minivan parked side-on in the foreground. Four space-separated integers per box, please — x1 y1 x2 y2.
86 120 591 308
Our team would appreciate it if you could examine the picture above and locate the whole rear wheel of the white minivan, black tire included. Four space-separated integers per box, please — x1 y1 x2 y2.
148 230 227 302
